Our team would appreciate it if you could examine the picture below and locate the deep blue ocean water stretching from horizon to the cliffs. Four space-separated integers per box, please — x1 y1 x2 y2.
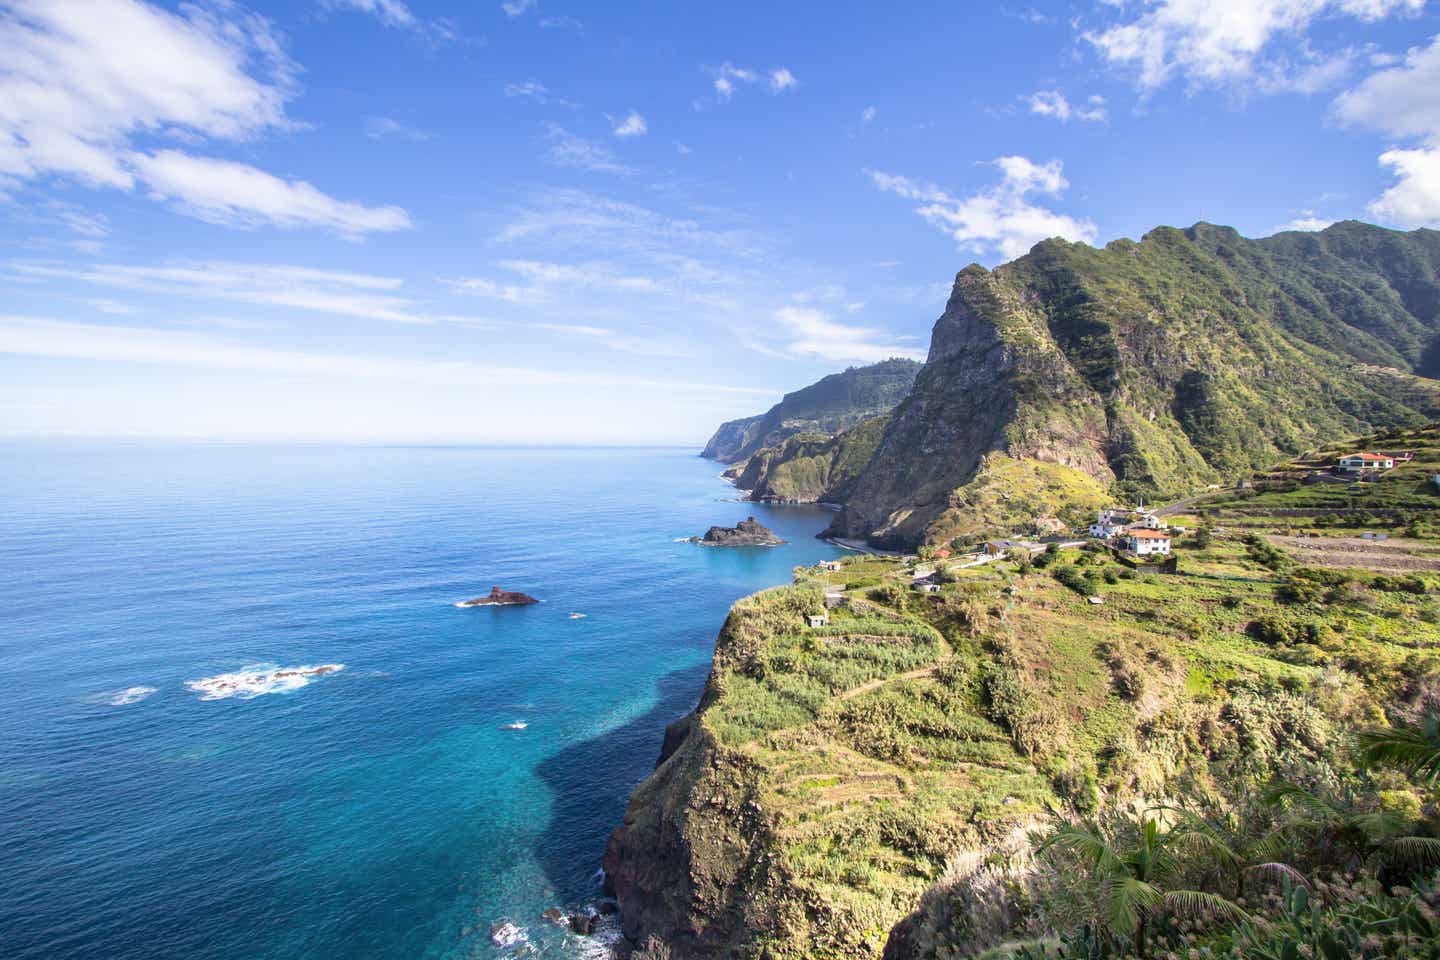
0 443 835 960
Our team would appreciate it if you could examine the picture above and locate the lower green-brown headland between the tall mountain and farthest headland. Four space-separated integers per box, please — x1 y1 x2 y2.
726 416 887 504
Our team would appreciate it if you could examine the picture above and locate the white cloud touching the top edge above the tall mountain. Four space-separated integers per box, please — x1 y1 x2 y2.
1083 0 1424 91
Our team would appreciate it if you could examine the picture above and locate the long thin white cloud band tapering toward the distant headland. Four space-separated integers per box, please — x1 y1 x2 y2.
0 315 773 396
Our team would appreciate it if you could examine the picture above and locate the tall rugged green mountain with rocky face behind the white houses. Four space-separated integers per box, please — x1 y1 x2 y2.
831 223 1440 545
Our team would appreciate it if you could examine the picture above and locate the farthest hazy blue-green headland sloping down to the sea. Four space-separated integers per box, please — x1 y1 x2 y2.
701 360 920 463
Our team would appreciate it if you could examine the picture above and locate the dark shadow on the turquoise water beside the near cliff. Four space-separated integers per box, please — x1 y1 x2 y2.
536 662 710 904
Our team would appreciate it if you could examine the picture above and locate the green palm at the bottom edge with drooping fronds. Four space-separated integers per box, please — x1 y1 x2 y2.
1037 810 1248 957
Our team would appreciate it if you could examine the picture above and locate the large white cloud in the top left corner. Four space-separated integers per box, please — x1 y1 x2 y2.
0 0 408 236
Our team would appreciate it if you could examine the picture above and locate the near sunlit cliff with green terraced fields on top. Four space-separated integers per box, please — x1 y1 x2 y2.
605 538 1440 960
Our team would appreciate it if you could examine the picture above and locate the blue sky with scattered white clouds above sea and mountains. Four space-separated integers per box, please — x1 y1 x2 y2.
0 0 1440 443
